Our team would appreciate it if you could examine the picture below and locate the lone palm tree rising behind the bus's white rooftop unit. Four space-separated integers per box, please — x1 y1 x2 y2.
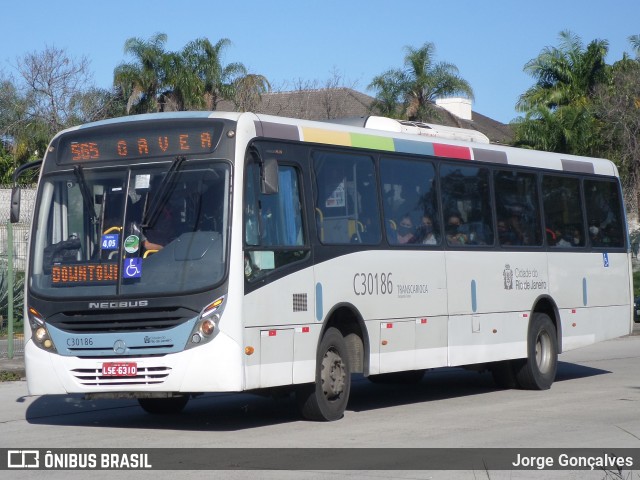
369 42 473 120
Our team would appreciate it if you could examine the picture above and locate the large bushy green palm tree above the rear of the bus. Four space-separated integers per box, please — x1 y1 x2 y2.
513 31 609 155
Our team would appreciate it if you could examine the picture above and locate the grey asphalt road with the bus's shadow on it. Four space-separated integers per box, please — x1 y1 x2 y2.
0 336 640 480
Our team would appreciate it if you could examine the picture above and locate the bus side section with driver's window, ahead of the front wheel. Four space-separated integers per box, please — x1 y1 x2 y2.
243 154 319 388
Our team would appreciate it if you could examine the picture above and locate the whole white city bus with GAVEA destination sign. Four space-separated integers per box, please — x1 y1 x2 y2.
14 112 632 420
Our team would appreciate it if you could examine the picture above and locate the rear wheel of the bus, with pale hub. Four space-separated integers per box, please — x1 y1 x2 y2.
514 313 558 390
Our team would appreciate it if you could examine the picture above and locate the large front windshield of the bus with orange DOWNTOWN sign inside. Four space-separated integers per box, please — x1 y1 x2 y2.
31 157 230 298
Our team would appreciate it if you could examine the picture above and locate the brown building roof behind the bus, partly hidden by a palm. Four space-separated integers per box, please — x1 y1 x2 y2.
218 88 513 145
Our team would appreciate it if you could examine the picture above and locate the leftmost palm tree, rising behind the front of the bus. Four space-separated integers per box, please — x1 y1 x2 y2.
114 33 171 113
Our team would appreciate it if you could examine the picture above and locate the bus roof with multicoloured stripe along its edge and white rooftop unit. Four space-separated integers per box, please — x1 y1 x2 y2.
54 111 618 176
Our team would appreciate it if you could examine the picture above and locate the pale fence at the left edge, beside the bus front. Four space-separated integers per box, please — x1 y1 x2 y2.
0 186 36 358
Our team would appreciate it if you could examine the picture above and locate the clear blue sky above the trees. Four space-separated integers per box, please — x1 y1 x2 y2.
0 0 640 123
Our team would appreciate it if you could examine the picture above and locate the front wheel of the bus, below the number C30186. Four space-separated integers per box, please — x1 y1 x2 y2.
296 328 351 422
